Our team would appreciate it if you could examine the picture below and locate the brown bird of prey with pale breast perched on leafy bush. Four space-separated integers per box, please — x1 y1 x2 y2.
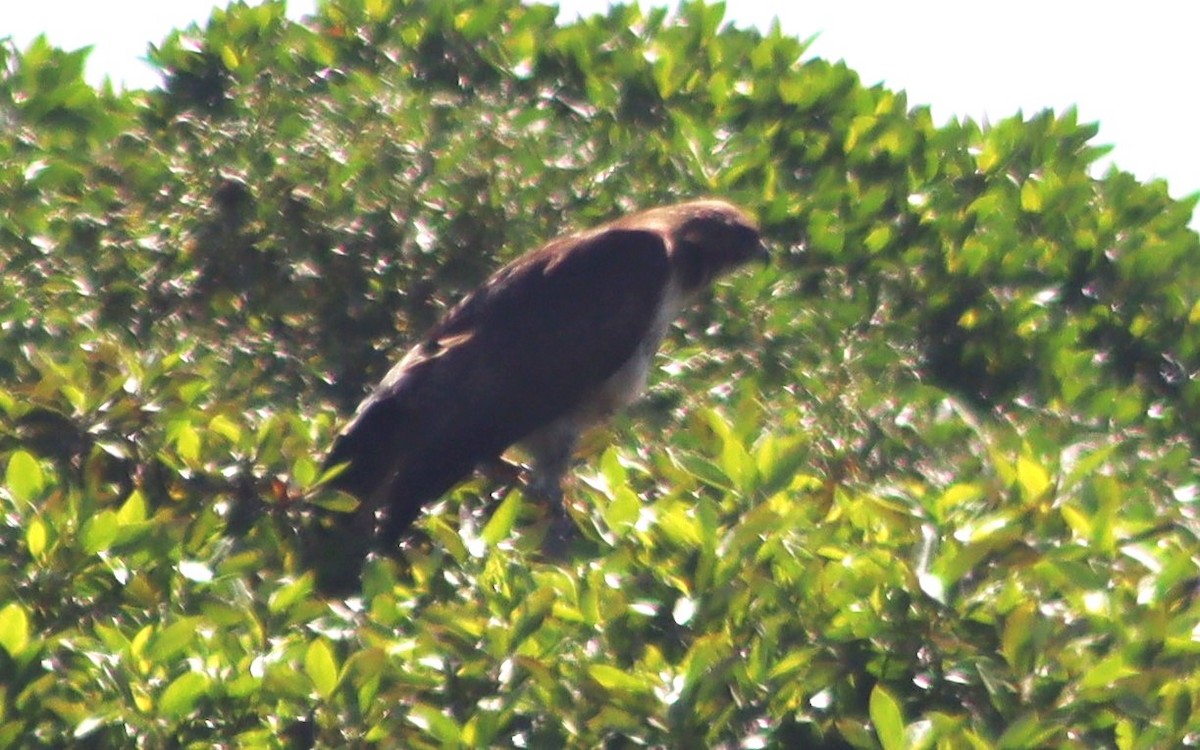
310 200 767 593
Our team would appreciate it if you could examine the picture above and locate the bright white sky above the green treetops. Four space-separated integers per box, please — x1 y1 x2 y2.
0 0 1200 227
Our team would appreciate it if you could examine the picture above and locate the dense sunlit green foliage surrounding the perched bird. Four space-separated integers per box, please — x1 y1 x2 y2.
0 0 1200 750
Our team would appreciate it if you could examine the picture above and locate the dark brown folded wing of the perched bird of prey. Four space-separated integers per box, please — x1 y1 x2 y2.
326 229 670 542
